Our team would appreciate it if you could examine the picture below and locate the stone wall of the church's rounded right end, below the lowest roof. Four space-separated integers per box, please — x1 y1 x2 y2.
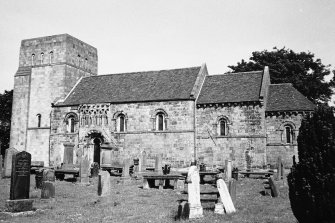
266 113 302 167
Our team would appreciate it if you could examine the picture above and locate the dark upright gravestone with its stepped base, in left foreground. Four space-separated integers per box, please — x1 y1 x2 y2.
6 151 33 212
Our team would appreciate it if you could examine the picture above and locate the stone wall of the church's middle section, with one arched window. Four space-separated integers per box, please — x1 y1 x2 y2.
197 104 266 168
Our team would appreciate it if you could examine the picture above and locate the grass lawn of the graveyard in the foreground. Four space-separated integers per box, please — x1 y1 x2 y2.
0 175 296 223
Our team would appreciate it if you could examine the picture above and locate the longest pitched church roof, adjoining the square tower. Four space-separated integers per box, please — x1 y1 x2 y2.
58 67 201 105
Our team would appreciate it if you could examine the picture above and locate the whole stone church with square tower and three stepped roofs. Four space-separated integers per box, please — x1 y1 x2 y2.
10 34 314 168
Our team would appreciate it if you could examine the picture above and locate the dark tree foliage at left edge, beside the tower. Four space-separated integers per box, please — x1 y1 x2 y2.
0 90 13 158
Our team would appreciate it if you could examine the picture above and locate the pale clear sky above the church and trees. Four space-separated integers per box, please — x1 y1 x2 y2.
0 0 335 93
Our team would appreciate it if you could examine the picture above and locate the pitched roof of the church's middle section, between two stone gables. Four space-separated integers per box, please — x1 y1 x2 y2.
197 71 263 104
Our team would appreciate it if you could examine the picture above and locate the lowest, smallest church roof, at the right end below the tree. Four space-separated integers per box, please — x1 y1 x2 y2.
266 83 315 111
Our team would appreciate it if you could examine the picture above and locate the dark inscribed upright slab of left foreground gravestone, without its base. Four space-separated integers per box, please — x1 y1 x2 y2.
10 151 31 200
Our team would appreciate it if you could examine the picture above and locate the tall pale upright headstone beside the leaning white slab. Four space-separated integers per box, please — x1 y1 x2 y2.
187 165 203 218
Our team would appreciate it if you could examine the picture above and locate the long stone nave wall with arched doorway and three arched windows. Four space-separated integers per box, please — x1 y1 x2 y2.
50 101 194 167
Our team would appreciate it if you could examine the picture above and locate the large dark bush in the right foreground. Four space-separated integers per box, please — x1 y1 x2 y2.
287 106 335 223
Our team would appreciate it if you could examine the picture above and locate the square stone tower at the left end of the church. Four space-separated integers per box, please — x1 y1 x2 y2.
10 34 98 166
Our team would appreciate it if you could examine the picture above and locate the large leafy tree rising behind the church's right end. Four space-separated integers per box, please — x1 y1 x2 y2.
228 47 335 104
